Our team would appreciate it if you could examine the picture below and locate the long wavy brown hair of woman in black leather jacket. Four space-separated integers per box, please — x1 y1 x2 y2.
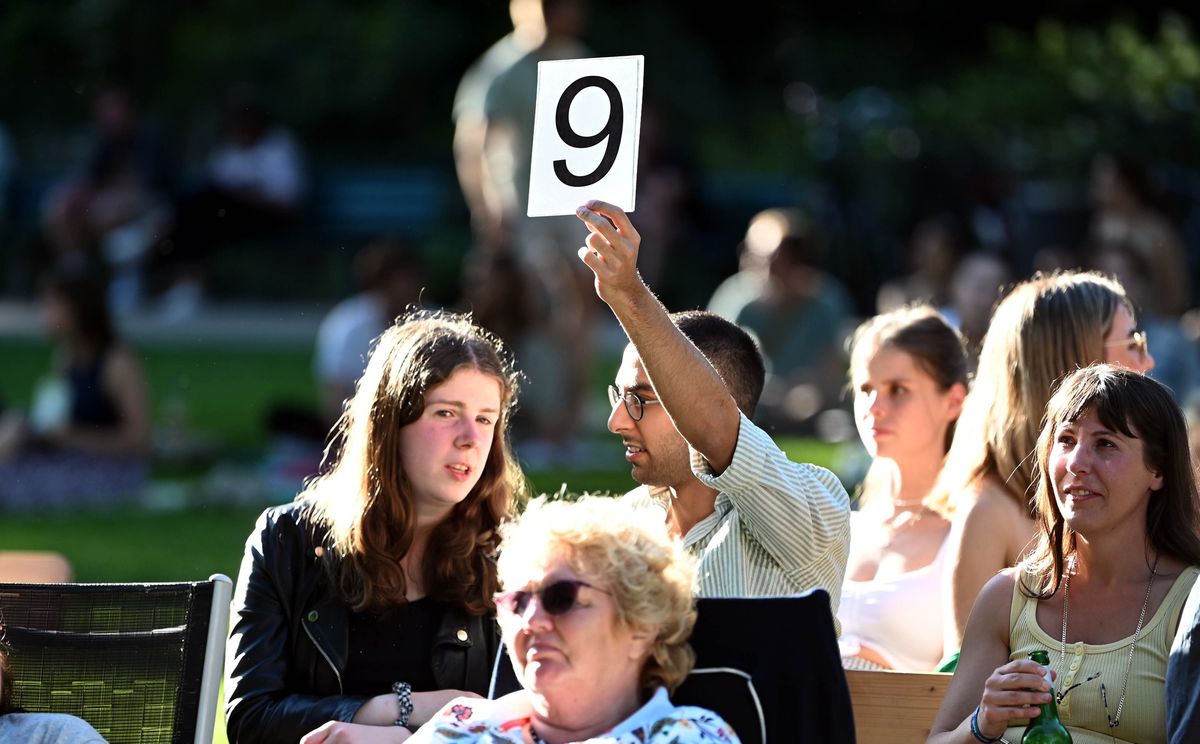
298 312 526 614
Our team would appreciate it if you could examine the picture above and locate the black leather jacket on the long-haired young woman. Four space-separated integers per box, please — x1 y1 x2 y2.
224 503 499 744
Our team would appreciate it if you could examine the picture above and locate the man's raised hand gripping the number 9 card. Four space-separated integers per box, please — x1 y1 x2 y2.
575 200 648 310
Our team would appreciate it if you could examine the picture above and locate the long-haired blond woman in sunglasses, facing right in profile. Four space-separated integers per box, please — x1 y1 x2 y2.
929 271 1154 658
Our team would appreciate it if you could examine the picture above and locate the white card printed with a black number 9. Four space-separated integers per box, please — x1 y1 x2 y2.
528 55 643 217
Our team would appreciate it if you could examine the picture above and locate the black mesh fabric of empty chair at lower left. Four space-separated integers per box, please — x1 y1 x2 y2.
0 582 212 744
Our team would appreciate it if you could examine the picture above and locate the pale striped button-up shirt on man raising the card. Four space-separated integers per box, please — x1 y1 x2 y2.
628 415 850 634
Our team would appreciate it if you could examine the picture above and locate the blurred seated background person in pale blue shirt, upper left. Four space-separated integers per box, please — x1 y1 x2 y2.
158 88 306 319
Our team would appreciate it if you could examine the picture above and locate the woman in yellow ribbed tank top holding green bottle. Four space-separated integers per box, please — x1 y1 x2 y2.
929 365 1200 744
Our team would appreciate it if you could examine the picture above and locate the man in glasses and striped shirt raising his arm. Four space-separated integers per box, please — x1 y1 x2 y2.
576 202 850 623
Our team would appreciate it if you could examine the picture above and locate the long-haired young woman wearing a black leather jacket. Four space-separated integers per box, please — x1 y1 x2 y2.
224 313 523 744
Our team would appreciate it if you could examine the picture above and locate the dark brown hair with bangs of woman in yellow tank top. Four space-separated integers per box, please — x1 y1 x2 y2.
1021 364 1200 599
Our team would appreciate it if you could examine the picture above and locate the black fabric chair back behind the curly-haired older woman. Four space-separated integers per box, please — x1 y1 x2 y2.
491 590 854 744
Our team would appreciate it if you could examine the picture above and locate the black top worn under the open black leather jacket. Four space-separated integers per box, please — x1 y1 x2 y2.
343 598 445 695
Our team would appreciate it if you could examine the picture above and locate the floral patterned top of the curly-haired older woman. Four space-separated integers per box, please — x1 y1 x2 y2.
408 688 740 744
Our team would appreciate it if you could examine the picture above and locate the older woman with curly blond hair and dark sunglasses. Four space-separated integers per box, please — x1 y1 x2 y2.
412 498 738 744
